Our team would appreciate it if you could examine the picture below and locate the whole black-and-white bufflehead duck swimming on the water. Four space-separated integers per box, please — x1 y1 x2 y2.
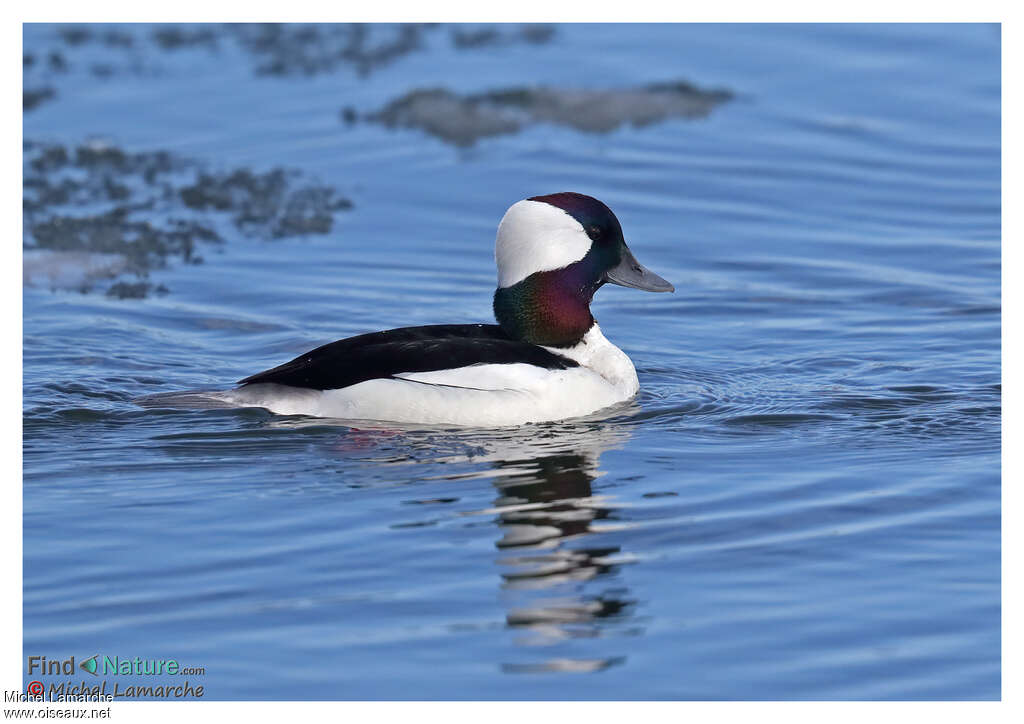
172 191 675 426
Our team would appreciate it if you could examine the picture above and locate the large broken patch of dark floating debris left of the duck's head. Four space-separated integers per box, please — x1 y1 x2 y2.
23 141 351 299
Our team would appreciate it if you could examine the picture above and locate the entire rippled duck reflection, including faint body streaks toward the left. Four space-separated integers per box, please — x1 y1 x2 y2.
262 413 639 673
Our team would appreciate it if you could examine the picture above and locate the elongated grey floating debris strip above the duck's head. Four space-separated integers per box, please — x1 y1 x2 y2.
366 81 732 146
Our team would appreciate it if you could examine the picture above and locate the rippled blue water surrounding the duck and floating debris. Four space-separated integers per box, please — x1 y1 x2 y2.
24 25 1001 699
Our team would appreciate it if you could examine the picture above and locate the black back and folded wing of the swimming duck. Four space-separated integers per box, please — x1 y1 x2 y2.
239 325 579 390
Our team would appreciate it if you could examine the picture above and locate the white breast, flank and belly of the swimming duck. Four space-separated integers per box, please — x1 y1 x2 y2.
221 325 639 426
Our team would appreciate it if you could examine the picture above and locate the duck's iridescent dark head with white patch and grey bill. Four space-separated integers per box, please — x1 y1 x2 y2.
495 191 675 347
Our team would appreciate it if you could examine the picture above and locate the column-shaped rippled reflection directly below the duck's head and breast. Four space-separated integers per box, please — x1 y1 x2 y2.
475 425 634 673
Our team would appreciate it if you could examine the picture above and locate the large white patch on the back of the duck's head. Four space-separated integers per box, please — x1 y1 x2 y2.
495 199 591 287
